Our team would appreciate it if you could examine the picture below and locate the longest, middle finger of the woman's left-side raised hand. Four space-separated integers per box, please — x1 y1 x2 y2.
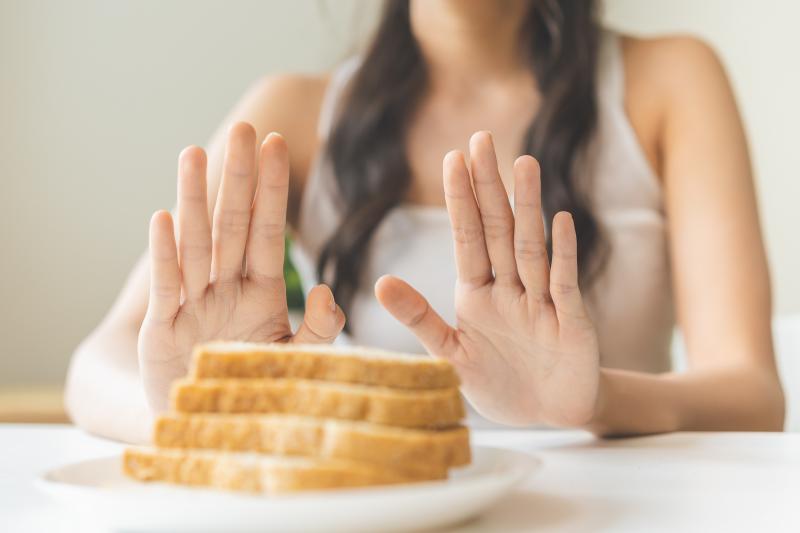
211 122 256 282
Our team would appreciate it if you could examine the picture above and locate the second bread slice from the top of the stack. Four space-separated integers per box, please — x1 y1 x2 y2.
171 379 464 428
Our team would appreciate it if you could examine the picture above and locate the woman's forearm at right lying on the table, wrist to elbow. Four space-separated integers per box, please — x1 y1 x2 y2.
588 367 784 436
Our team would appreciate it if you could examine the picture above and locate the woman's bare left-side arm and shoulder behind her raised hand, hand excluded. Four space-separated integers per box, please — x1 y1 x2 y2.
65 76 327 442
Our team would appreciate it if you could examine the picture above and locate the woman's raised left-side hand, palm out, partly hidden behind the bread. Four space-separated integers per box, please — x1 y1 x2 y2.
138 123 344 412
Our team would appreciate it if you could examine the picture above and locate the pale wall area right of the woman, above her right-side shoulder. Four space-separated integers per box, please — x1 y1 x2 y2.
606 0 800 313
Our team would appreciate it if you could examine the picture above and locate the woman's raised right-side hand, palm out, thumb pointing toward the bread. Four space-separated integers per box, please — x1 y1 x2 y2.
375 132 600 426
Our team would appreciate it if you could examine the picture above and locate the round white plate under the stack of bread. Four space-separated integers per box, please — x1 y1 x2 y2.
39 446 541 532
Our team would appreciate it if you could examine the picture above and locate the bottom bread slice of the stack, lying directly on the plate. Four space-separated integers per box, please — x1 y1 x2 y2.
123 448 447 493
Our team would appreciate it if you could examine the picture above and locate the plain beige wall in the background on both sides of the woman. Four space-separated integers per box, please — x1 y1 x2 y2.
0 0 800 385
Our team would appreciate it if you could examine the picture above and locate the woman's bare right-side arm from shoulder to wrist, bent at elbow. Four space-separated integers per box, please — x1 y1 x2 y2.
591 38 784 434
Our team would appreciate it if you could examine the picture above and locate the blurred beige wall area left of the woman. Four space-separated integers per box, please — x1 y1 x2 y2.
0 0 380 385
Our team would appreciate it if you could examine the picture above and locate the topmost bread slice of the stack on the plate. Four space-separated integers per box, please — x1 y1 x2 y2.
189 342 459 389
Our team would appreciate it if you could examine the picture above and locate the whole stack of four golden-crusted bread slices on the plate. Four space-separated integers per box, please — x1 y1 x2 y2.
123 342 470 493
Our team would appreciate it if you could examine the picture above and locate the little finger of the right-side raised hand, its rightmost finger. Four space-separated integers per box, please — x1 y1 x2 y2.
550 211 586 323
